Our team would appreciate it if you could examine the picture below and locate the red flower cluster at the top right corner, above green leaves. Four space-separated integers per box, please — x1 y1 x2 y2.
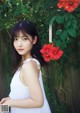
57 0 80 12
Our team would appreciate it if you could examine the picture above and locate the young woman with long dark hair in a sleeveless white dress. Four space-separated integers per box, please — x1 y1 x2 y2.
0 21 51 113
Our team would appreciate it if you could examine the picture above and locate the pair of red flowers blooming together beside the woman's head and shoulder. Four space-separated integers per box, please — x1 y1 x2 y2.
40 44 63 62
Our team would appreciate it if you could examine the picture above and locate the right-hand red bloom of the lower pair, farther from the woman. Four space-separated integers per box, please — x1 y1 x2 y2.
51 47 63 60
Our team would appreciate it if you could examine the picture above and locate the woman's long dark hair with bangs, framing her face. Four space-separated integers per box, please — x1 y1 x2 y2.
11 20 46 69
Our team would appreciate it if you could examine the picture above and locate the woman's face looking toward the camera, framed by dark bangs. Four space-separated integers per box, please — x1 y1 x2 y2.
13 31 33 57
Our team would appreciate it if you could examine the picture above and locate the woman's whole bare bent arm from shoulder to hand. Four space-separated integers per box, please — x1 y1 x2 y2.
1 61 44 108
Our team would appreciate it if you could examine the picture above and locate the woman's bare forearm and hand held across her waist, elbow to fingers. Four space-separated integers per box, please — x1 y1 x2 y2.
3 99 43 108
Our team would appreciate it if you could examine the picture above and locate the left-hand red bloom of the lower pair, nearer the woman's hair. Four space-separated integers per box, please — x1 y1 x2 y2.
40 44 53 62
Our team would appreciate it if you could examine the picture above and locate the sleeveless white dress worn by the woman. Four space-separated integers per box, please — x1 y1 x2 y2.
9 58 51 113
